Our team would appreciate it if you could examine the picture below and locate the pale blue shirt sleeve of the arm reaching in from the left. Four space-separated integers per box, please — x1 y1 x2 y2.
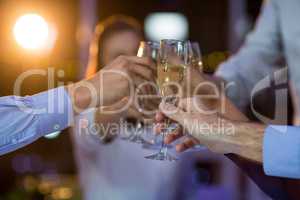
0 87 73 155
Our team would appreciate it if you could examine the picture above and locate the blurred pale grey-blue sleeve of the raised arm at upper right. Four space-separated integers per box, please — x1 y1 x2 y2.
215 0 284 110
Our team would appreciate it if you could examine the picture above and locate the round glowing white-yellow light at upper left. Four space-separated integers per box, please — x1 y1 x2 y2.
13 14 50 50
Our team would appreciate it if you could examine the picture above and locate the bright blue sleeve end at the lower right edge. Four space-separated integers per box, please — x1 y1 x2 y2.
263 126 300 178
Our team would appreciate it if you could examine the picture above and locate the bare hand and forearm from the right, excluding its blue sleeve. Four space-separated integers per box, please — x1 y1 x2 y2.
160 98 265 162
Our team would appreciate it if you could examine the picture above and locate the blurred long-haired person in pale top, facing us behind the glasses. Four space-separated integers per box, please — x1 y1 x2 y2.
72 15 196 200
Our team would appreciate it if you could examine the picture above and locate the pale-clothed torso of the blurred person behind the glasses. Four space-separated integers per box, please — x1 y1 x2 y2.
72 113 193 200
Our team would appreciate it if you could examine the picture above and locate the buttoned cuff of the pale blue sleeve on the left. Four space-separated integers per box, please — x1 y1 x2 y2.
31 86 73 135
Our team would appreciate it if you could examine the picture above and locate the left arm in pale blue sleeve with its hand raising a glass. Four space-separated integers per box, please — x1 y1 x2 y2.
0 56 153 155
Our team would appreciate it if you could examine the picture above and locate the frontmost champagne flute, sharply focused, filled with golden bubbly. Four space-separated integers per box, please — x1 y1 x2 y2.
145 40 189 161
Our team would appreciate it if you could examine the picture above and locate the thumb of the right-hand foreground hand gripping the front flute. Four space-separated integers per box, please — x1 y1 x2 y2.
159 101 185 123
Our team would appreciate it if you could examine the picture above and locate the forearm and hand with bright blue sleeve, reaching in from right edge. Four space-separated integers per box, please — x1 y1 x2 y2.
160 99 300 178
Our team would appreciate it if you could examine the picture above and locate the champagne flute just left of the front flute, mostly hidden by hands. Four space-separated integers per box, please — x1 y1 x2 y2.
129 41 159 146
